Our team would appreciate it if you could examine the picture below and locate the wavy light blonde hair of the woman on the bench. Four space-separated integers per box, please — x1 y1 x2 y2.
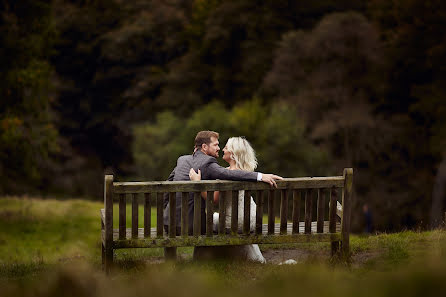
226 137 257 171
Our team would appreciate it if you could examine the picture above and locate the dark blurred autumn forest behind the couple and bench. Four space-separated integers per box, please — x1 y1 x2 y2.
0 0 446 231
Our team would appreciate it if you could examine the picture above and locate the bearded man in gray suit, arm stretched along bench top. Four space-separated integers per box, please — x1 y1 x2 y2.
164 131 282 235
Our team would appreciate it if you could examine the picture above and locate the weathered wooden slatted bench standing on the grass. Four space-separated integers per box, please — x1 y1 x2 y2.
101 168 353 271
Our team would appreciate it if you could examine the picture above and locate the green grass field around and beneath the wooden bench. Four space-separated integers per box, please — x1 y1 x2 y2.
0 197 446 296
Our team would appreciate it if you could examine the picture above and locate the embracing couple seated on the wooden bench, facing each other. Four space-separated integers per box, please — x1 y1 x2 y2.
164 131 282 263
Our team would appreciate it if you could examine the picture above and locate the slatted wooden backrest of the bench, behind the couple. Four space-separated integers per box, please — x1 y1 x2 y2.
104 168 353 248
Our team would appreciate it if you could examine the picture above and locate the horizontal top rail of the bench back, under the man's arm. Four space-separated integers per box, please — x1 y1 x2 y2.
113 176 344 194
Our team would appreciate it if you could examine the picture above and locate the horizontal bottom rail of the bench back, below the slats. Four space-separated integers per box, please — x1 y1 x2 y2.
114 233 340 249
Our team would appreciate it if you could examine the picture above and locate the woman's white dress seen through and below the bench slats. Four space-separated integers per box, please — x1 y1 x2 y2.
213 190 266 263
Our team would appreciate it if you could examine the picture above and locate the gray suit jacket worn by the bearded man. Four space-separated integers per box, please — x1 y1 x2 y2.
164 151 258 234
